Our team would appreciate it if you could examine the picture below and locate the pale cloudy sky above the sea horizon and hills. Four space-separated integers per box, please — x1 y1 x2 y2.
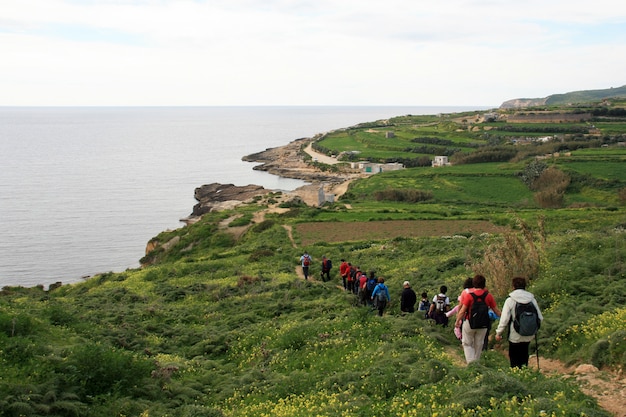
0 0 626 107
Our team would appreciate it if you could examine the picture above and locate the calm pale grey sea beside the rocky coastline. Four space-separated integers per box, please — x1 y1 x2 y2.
0 106 489 288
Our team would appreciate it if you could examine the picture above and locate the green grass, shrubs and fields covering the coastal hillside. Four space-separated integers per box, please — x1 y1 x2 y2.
0 101 626 417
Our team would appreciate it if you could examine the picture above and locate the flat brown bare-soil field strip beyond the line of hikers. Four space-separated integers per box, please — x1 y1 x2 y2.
295 220 507 246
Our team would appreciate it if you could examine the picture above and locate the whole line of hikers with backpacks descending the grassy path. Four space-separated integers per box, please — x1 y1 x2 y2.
300 252 543 368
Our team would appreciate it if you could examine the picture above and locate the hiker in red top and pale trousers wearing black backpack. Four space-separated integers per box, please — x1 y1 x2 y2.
455 275 501 364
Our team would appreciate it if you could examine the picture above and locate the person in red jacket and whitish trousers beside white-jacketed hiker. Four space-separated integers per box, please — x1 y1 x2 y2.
455 275 501 363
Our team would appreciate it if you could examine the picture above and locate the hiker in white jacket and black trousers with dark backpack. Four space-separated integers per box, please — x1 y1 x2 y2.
496 277 543 368
